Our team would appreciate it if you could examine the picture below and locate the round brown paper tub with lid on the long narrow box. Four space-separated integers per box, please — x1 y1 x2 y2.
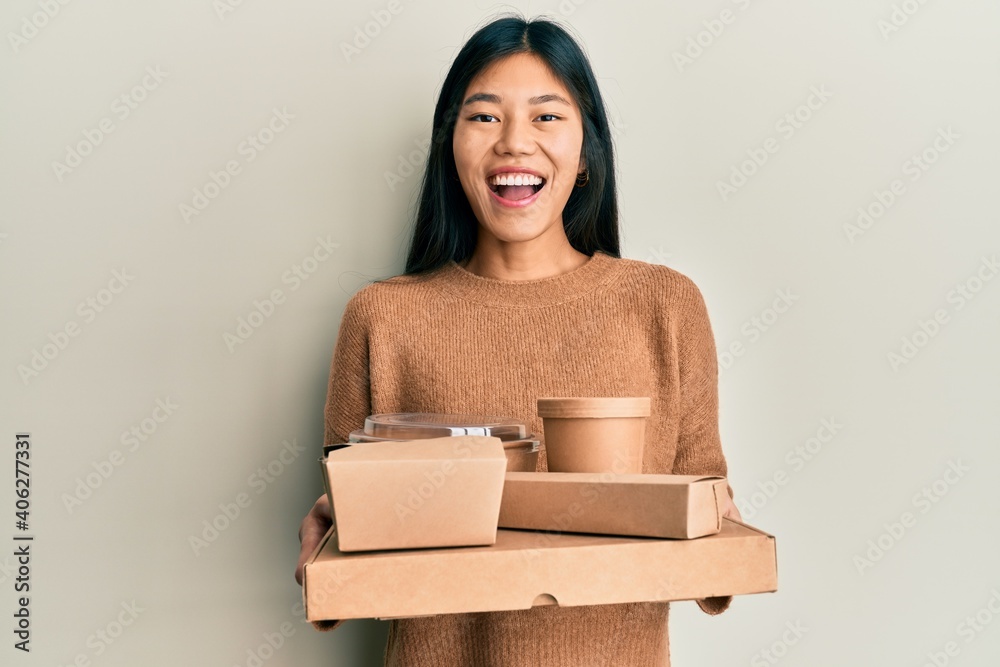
538 397 650 474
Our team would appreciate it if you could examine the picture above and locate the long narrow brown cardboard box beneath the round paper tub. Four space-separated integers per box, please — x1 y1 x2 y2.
499 472 729 539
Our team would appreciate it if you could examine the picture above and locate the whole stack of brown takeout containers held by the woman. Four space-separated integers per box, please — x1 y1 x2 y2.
303 398 777 621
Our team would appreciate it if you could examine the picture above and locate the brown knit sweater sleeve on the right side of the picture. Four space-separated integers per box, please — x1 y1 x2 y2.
673 279 733 615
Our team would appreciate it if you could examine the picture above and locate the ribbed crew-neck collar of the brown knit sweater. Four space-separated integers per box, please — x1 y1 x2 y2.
438 252 623 308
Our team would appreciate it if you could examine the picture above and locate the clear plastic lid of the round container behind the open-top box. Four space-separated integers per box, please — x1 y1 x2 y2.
365 412 528 440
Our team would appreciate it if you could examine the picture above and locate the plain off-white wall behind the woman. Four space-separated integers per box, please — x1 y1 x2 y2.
0 0 1000 667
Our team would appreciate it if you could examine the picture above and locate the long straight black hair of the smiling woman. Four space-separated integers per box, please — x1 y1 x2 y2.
406 17 621 275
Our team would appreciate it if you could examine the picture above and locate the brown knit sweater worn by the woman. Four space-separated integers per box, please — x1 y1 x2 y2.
325 253 730 667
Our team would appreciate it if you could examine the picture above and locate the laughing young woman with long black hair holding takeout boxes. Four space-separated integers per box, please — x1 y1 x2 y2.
296 18 739 667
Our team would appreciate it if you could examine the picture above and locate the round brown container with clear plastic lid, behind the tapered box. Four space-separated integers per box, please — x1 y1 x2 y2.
349 412 540 472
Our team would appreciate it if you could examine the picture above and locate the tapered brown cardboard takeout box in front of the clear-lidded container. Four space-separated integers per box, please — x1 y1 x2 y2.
322 436 507 552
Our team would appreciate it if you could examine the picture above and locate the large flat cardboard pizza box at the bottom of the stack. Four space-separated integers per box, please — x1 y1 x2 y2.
303 519 777 621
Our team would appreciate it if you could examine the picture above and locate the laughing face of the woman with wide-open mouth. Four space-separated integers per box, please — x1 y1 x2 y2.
454 53 584 249
